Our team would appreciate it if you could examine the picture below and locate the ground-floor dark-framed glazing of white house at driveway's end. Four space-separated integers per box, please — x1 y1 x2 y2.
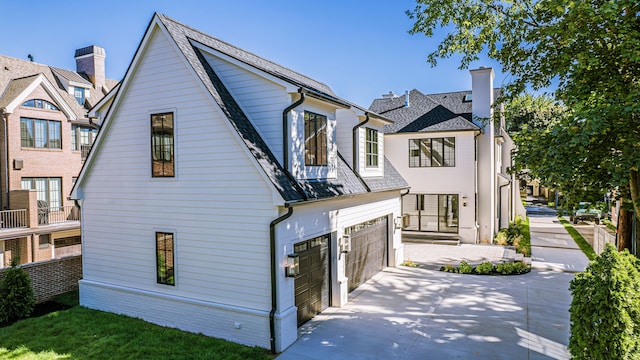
402 194 459 233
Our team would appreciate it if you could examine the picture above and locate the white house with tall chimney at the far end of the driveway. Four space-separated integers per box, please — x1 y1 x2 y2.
370 68 524 243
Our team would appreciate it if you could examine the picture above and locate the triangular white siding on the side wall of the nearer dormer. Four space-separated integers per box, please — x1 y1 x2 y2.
205 53 292 164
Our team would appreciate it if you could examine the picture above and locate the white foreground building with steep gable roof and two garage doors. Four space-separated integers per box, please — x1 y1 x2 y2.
72 14 408 351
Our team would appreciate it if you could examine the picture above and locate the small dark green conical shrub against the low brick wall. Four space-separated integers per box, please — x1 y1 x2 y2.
0 258 36 322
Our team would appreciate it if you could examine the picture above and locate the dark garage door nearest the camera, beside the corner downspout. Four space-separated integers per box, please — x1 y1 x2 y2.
293 235 329 326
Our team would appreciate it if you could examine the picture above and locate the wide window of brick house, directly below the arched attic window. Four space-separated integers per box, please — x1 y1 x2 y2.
20 118 62 149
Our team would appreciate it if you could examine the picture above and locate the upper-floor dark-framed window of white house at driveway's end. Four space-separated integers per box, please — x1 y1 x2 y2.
409 137 456 167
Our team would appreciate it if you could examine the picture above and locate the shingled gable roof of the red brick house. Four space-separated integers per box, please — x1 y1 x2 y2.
0 55 117 119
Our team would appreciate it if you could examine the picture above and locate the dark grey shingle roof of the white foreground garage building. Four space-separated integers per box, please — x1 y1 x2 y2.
157 14 408 202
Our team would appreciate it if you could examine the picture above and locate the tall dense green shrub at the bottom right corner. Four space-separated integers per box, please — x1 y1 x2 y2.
568 244 640 359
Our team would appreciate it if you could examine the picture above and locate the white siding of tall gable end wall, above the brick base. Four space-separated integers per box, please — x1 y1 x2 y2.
82 30 277 311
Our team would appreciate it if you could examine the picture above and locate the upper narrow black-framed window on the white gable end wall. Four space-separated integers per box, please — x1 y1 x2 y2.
151 112 175 177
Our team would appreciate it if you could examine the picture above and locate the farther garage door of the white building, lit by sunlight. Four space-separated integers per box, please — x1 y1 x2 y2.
345 216 388 291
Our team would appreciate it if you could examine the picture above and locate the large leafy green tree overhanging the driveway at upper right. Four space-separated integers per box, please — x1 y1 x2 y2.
407 0 640 224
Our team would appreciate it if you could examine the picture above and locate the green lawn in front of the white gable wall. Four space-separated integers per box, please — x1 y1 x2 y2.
0 293 274 360
